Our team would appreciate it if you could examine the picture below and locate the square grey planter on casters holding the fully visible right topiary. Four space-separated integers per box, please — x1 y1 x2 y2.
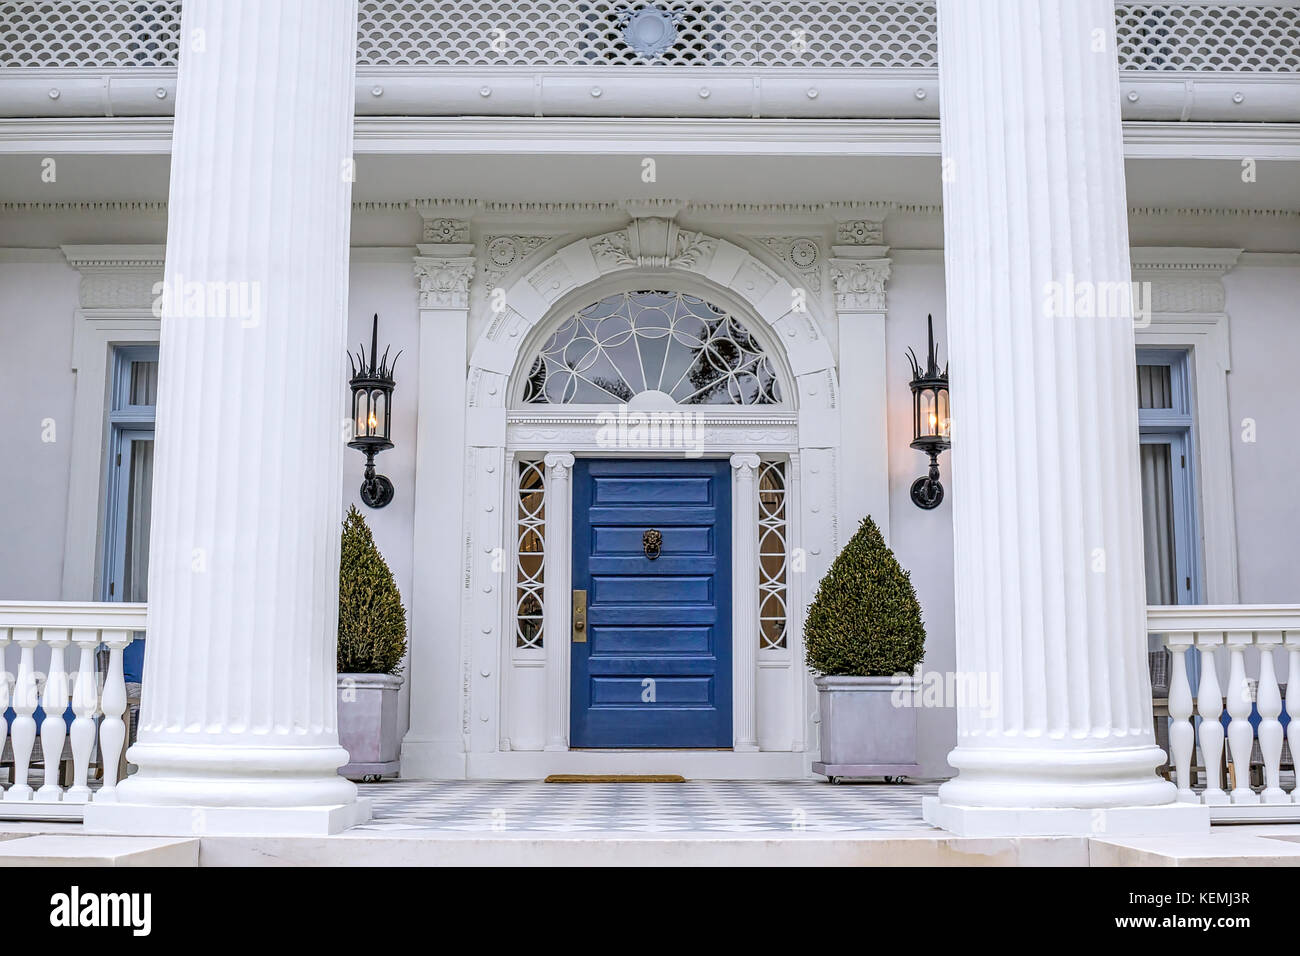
813 676 920 783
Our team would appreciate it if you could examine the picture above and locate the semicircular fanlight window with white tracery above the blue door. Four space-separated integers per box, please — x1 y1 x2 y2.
524 291 781 405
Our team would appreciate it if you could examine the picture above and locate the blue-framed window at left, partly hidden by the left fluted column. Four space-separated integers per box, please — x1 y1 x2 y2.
101 345 159 683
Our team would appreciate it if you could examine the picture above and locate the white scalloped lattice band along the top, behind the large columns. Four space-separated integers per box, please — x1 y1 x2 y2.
0 0 1300 73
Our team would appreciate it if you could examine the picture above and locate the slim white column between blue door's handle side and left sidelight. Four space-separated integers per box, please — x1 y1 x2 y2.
542 453 573 750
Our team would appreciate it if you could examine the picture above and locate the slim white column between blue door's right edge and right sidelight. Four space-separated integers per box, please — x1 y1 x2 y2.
731 455 758 753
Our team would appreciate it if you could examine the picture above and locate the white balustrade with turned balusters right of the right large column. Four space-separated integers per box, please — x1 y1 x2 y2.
1147 605 1300 821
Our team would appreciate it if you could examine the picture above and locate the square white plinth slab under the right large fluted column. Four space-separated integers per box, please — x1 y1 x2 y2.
920 797 1210 836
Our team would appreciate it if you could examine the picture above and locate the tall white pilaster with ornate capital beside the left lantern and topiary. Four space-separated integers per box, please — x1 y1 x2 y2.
402 208 475 779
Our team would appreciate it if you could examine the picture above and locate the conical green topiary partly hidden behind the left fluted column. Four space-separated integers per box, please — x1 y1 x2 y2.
338 505 406 675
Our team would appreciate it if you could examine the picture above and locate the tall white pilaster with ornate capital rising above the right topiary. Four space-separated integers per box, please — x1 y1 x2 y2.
831 216 891 538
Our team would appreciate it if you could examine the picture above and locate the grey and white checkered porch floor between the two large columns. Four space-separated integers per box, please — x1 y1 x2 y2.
359 780 939 832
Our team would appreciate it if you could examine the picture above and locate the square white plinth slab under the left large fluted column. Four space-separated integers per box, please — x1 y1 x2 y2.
85 799 371 836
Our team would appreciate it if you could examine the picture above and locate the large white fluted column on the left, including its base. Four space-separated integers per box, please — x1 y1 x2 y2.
87 0 368 832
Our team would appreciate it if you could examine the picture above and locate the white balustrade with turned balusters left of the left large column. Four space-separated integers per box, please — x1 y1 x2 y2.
0 601 146 819
